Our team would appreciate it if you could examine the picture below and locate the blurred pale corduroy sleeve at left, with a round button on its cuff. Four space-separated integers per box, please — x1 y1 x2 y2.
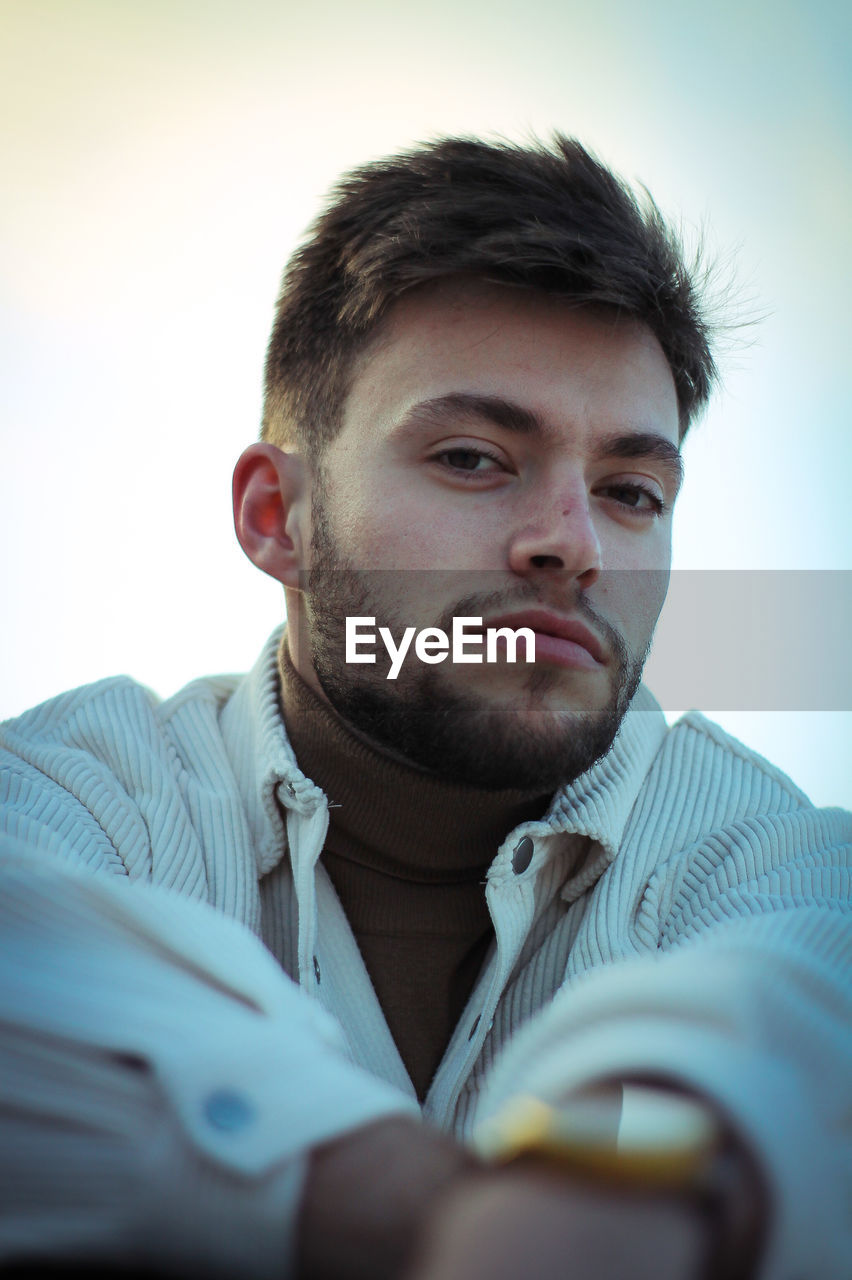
0 833 418 1280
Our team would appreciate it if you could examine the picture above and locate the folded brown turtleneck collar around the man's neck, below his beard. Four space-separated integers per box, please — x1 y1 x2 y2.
279 637 550 883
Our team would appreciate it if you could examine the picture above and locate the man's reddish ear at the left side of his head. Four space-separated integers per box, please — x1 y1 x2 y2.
233 443 310 589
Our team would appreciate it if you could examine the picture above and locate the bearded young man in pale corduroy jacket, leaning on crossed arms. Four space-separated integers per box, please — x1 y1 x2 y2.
0 138 852 1280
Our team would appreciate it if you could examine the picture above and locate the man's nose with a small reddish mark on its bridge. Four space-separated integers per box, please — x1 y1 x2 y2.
509 485 603 590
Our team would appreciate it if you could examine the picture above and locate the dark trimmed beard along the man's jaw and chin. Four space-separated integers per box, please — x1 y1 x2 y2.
302 488 645 794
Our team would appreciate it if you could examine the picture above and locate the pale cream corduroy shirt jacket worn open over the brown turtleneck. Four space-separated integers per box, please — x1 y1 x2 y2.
0 624 852 1280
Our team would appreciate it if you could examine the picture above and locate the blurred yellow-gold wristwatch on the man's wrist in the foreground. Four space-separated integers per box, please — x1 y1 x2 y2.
472 1084 765 1280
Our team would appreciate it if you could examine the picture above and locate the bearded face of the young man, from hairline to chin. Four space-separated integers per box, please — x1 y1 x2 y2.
294 280 679 792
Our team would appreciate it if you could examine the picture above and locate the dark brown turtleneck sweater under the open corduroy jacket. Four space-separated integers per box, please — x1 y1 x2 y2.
279 645 549 1101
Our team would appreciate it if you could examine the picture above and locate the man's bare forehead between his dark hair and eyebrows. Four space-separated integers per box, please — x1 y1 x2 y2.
340 279 679 455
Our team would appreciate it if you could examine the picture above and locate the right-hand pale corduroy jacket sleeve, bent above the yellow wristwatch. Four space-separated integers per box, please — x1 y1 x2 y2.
477 812 852 1280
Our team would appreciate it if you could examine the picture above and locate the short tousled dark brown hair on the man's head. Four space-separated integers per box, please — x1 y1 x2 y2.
262 134 716 457
